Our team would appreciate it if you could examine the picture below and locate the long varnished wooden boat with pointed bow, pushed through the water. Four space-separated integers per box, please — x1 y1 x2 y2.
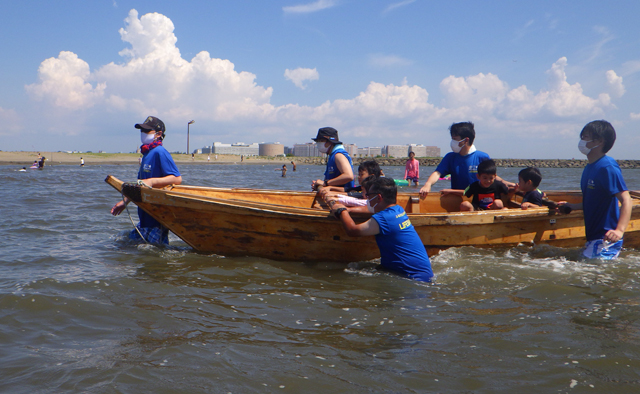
105 176 640 262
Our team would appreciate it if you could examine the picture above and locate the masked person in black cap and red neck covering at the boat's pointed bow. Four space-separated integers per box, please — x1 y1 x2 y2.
111 116 182 244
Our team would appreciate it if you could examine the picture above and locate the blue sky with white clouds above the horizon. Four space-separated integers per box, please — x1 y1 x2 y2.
0 0 640 159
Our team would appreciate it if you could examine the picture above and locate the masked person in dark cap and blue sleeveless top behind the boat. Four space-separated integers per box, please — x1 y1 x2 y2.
311 127 354 190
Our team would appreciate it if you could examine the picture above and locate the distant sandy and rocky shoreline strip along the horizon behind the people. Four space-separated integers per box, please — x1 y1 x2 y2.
0 151 640 168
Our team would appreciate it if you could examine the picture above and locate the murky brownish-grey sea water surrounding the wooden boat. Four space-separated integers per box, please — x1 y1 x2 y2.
0 164 640 394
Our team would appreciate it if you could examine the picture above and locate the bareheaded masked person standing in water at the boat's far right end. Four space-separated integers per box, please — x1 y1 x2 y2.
558 120 631 260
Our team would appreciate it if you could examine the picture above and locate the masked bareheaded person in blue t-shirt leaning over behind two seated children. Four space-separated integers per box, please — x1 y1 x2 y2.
420 122 515 198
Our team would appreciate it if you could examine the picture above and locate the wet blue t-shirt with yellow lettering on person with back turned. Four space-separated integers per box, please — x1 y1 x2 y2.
372 205 433 282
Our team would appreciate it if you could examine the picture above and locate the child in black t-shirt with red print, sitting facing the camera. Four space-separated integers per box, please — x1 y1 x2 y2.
460 159 509 212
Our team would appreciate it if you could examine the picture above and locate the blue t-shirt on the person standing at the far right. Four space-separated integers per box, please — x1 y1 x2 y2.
580 156 628 241
